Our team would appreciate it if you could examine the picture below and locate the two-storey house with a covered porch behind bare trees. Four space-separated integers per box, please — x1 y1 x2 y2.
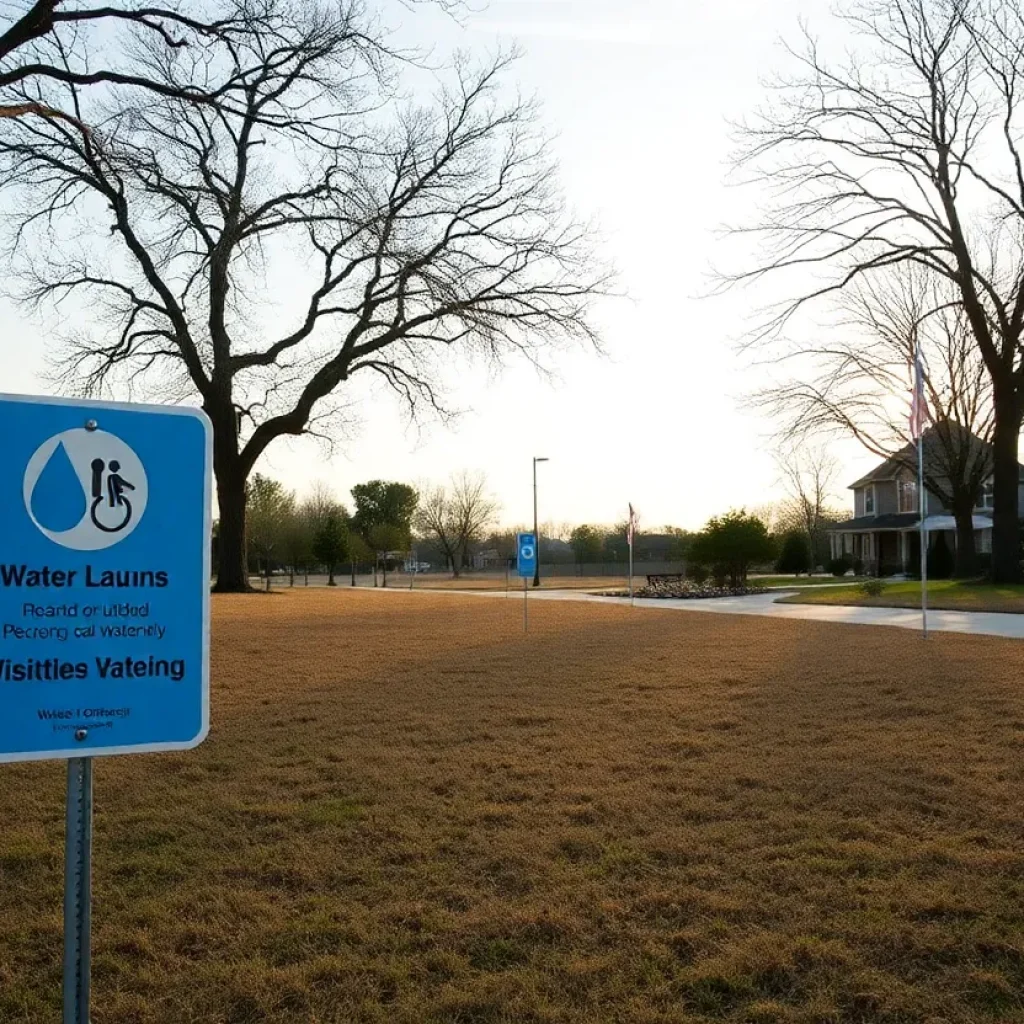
828 431 1024 575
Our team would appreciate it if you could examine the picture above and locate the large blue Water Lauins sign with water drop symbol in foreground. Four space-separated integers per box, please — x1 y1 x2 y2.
0 395 212 761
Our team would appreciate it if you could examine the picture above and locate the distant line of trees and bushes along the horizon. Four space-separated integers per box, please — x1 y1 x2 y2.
228 464 851 589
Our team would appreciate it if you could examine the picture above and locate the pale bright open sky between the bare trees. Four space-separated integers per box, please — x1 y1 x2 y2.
0 0 878 528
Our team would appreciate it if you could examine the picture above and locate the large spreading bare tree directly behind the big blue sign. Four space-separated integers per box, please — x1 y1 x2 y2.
0 0 606 590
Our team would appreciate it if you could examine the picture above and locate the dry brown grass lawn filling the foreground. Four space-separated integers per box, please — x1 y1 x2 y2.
0 591 1024 1024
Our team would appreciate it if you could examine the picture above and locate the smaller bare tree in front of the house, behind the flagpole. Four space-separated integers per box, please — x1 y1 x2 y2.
755 267 993 577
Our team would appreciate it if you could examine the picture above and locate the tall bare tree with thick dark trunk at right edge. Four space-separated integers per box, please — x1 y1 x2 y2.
731 0 1024 581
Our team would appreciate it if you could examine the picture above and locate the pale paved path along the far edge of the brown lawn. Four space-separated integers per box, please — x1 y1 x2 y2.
382 590 1024 639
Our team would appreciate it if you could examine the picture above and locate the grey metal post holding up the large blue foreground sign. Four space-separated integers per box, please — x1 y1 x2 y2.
63 758 92 1024
